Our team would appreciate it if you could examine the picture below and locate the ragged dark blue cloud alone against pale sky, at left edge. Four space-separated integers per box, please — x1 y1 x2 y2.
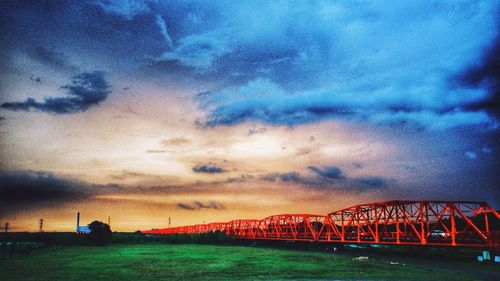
1 71 111 114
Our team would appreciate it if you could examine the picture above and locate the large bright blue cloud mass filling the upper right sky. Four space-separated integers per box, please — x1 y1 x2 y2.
173 1 498 130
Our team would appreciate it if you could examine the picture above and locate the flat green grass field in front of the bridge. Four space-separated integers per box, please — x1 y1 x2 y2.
0 244 496 281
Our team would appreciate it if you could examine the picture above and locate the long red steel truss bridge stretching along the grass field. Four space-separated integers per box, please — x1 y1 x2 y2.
142 201 500 249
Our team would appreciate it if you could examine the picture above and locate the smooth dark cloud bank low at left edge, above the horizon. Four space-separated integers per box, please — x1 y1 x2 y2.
0 171 91 214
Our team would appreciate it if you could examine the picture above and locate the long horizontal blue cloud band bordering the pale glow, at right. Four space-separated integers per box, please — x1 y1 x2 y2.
195 78 497 130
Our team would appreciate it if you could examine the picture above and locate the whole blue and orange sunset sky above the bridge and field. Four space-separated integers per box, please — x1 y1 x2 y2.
0 0 500 231
